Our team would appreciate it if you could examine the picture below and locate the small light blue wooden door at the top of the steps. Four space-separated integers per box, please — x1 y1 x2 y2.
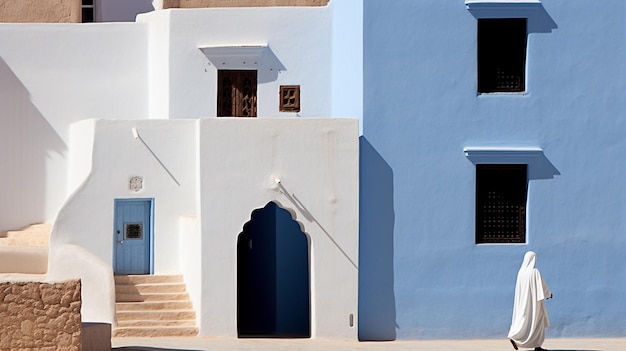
113 200 152 274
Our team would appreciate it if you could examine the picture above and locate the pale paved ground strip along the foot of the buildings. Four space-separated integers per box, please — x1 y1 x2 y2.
112 337 626 351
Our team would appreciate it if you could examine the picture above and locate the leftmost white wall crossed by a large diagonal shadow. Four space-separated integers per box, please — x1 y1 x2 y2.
0 24 147 230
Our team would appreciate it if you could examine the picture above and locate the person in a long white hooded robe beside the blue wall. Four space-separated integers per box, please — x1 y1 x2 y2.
508 251 552 348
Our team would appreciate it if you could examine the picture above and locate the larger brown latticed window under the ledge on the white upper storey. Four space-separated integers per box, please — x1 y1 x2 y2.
217 70 257 117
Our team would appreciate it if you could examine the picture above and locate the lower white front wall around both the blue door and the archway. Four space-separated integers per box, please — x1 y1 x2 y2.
50 118 359 340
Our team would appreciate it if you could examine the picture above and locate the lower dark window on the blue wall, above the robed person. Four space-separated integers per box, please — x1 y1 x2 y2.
476 164 528 244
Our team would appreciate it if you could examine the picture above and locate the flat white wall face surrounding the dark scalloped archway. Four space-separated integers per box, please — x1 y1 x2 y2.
200 118 359 340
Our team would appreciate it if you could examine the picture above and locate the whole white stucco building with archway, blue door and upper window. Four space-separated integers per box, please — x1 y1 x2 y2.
0 2 362 339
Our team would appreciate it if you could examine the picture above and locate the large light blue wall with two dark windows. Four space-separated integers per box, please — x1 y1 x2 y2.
359 0 626 340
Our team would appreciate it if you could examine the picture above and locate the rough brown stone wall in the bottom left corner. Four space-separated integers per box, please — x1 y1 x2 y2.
0 280 81 351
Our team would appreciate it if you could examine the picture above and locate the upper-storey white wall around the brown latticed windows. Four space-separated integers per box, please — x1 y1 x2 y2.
138 7 332 118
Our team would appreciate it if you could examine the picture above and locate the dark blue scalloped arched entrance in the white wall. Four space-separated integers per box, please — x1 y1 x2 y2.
237 202 311 338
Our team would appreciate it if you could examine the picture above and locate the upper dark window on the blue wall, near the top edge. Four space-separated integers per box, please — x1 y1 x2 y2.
478 18 526 93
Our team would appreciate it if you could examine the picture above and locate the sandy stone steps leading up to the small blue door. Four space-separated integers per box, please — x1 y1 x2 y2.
113 275 198 337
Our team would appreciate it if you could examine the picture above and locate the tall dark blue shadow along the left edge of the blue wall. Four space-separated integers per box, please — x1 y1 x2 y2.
359 136 397 341
